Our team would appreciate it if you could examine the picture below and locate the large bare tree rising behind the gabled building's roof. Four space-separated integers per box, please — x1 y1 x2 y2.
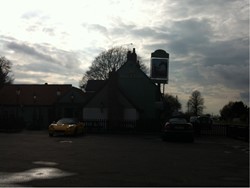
79 47 147 88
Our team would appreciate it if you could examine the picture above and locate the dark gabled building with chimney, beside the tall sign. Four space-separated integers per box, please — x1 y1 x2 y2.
83 49 162 130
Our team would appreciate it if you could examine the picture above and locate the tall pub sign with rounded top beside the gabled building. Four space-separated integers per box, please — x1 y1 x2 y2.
150 49 169 94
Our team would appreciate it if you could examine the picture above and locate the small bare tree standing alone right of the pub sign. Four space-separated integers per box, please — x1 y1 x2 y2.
187 90 205 116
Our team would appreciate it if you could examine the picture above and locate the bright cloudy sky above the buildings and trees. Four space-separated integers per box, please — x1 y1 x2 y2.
0 0 249 115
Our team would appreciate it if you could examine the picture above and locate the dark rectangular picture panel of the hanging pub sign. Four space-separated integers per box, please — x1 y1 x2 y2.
151 57 169 83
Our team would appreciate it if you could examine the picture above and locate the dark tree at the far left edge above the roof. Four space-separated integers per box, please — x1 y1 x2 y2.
0 57 14 88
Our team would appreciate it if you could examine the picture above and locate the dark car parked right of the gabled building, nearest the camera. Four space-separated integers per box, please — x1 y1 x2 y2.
162 117 194 142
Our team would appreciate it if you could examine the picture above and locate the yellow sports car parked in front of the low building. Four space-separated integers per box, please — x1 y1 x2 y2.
49 118 84 136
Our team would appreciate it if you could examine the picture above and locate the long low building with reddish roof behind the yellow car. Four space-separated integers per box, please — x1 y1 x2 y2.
0 83 86 129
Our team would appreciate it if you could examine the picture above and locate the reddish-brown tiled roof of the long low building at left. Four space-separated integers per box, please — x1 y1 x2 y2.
0 84 72 105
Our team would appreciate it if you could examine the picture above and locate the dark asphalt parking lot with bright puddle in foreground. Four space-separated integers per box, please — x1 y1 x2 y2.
0 131 249 187
